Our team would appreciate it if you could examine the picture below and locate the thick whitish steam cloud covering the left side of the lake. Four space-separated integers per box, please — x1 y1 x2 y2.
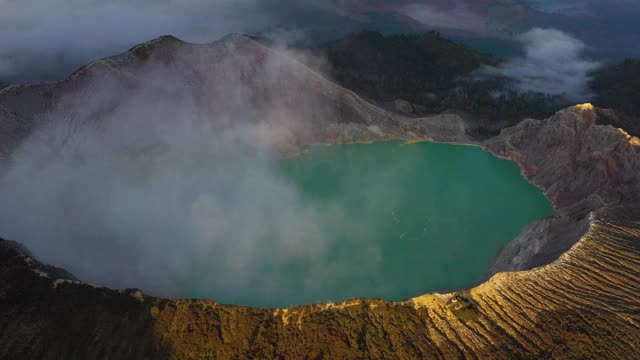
0 45 390 299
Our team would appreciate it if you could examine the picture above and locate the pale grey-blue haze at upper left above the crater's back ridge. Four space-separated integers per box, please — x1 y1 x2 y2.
0 0 272 81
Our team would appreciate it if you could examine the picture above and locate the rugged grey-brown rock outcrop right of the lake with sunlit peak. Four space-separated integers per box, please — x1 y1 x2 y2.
486 104 640 273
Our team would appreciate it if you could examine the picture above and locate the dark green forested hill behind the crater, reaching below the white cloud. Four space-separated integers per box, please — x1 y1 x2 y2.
321 31 569 122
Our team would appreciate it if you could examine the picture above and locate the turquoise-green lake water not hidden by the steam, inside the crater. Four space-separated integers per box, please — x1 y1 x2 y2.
179 142 552 307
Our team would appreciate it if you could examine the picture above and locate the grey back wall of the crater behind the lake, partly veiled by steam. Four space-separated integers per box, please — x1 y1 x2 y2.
0 35 476 159
